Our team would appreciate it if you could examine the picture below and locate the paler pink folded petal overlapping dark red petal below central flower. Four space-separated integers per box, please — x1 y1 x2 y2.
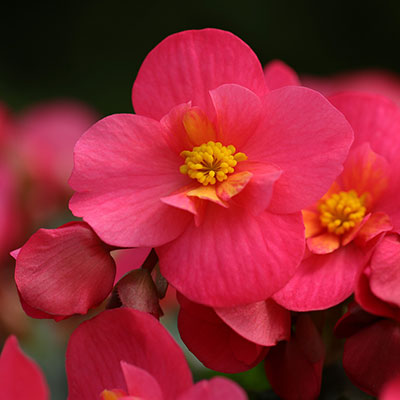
215 299 290 346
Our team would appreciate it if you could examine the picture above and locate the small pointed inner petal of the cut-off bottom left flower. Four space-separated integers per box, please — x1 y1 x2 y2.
121 361 164 400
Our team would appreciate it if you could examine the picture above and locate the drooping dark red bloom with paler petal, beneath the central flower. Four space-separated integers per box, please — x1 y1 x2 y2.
177 293 290 373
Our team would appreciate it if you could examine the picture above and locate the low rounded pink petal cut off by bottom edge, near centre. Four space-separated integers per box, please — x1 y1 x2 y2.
178 376 247 400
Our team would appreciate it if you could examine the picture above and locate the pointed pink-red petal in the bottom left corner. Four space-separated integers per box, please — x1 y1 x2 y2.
0 336 49 400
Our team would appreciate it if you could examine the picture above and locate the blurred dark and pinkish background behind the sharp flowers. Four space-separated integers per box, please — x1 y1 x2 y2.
0 0 400 400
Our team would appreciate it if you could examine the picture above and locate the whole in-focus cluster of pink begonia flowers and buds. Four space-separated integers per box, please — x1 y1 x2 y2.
5 29 400 400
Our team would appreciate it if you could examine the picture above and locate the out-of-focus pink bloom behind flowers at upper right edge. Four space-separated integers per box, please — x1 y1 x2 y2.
301 69 400 105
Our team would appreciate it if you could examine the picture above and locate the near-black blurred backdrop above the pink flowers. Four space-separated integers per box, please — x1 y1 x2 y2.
0 0 400 115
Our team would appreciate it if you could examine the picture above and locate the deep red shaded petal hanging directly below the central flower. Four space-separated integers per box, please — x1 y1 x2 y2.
178 295 267 373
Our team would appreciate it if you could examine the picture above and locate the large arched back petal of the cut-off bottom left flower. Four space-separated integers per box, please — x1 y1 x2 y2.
66 308 192 400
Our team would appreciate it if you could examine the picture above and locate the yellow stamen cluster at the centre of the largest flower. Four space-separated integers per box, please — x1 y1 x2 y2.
179 141 247 186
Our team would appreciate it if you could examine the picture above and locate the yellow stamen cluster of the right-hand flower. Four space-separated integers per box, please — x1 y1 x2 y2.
318 190 366 235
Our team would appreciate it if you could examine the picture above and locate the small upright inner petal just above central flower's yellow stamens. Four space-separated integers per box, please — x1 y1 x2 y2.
210 85 262 148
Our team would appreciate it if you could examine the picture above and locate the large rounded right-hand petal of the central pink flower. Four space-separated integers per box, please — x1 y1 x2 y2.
241 86 353 213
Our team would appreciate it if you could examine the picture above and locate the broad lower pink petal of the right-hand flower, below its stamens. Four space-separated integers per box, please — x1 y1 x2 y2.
273 245 367 311
